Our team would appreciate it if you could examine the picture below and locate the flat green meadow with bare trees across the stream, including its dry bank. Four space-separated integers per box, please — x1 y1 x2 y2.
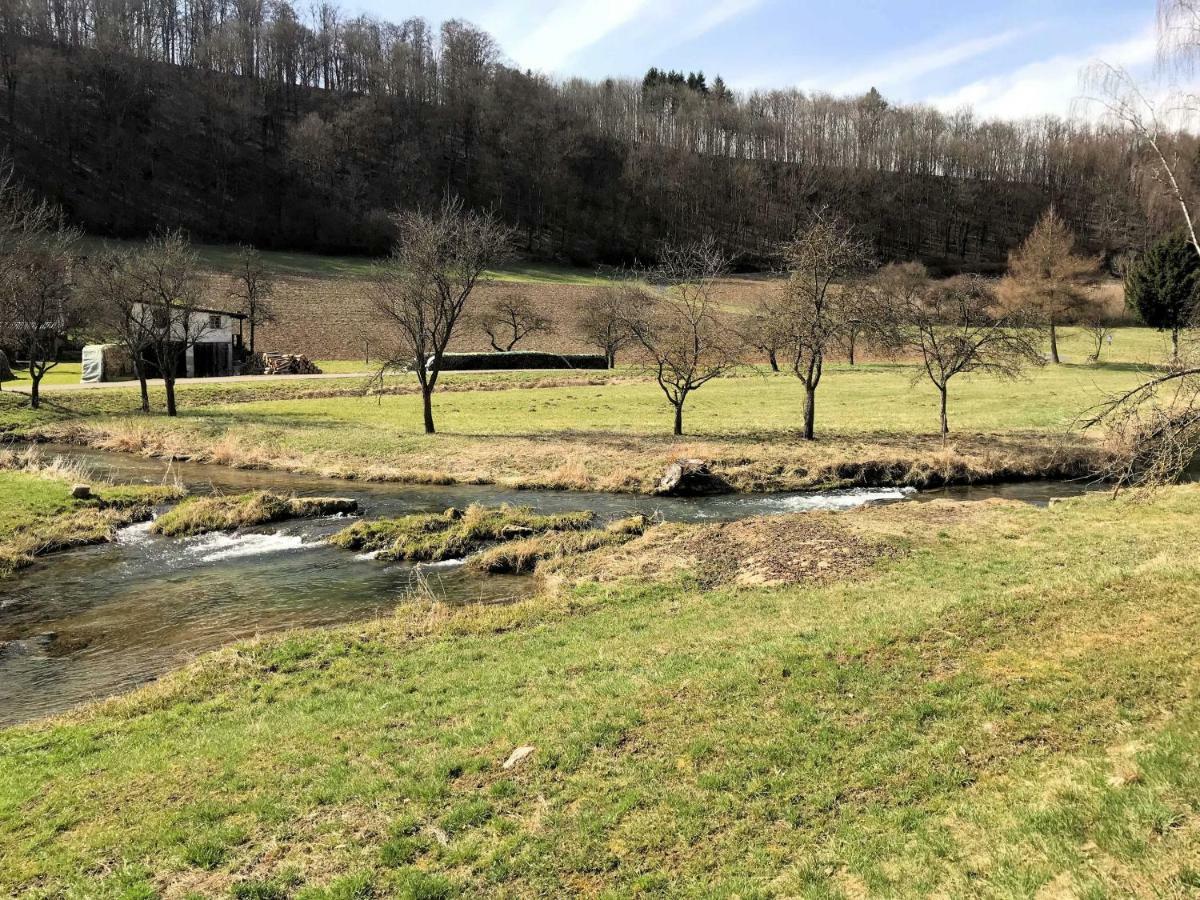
0 329 1166 491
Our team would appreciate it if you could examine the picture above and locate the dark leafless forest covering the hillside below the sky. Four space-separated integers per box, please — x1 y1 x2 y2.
0 0 1171 270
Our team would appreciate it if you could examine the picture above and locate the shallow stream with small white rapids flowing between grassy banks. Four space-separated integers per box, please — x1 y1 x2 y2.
0 448 1099 725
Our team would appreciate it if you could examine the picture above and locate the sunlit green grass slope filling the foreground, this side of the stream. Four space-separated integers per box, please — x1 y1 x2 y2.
0 487 1200 898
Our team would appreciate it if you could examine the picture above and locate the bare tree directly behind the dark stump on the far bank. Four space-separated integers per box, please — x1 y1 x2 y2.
625 241 740 436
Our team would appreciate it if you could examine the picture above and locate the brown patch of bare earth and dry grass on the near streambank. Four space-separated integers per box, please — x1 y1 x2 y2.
556 512 901 587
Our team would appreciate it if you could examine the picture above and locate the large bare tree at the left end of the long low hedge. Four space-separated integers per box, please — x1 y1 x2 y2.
376 198 512 434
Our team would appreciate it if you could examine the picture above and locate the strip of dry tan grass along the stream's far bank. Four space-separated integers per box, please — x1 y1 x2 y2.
40 419 1105 493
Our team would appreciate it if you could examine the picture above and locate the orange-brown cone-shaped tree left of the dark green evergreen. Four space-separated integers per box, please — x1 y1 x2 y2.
1000 206 1099 364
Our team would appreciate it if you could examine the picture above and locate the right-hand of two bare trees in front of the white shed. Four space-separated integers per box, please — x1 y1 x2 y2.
132 230 208 416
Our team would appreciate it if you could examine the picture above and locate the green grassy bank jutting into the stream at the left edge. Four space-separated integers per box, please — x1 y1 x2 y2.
0 450 182 580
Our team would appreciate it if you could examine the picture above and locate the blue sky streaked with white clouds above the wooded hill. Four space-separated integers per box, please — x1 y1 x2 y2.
347 0 1154 118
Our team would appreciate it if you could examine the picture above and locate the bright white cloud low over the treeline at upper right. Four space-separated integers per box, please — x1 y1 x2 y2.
928 28 1157 119
